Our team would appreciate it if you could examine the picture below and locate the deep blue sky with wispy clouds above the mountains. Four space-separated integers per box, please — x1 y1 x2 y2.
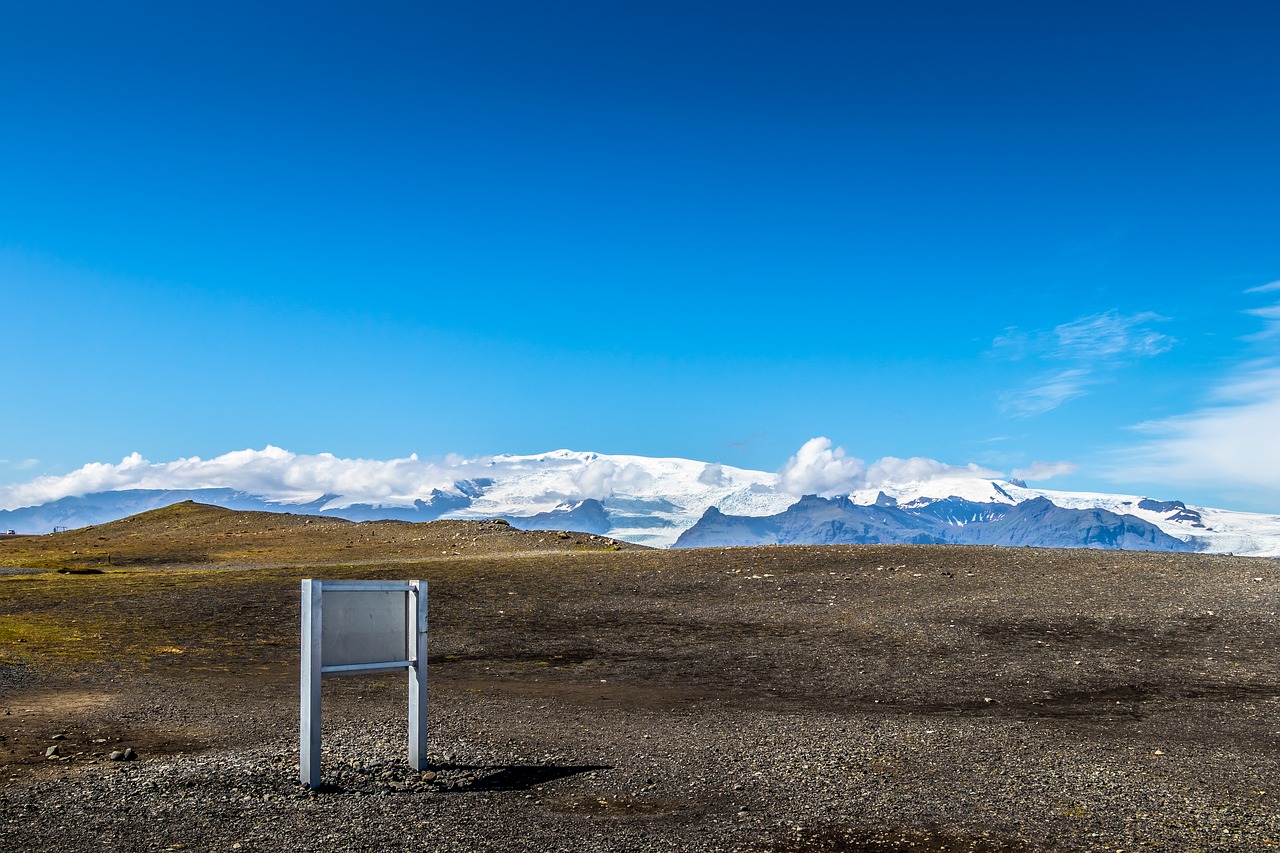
0 0 1280 512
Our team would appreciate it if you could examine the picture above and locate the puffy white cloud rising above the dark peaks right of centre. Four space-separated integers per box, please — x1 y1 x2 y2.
778 435 1001 497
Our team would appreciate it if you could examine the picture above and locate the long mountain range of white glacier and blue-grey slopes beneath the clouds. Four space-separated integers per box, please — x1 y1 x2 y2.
0 450 1280 556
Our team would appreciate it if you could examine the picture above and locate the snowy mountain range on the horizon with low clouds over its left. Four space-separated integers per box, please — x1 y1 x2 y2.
0 447 1280 556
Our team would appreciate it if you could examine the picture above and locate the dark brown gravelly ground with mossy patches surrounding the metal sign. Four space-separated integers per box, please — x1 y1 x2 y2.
0 502 1280 850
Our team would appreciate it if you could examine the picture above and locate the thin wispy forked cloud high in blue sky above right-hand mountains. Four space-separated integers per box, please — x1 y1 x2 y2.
991 310 1175 418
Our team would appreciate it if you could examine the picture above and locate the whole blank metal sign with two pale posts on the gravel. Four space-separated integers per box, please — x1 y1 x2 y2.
298 578 426 790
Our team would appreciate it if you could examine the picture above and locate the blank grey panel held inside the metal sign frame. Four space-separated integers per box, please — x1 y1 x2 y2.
320 589 410 666
